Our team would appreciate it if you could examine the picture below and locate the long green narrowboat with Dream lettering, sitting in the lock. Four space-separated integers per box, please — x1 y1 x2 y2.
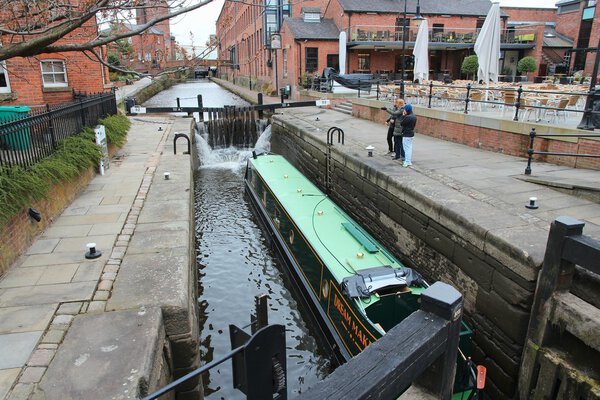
245 154 474 399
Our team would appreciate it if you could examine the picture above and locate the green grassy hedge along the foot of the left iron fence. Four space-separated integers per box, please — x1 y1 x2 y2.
0 114 131 225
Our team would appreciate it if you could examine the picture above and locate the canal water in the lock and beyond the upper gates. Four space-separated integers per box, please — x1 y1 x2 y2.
144 80 330 399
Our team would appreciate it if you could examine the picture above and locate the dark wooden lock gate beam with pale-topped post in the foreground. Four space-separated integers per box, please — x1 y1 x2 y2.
298 282 463 400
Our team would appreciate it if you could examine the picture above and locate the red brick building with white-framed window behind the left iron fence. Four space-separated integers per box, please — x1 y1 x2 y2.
0 19 110 106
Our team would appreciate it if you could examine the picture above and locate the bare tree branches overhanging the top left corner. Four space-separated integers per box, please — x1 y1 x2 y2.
0 0 213 61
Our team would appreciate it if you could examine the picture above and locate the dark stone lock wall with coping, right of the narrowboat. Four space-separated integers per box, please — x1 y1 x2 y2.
272 117 547 399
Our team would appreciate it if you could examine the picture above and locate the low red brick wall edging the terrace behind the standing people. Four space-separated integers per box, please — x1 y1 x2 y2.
352 103 600 170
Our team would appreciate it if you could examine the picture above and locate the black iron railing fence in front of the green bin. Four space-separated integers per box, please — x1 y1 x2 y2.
0 92 117 171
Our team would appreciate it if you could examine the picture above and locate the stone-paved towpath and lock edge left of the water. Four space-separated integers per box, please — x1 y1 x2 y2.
0 115 201 399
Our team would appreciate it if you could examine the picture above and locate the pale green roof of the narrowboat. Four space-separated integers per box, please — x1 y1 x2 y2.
250 154 410 283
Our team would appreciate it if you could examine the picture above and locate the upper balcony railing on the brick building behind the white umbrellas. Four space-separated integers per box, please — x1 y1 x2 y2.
348 25 536 44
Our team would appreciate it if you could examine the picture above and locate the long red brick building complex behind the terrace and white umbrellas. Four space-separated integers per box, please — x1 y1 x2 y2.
217 0 573 97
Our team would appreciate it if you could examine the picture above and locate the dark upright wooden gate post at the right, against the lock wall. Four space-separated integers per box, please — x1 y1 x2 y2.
519 217 585 399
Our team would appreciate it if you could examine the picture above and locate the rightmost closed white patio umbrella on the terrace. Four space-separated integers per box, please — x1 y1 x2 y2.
475 3 500 85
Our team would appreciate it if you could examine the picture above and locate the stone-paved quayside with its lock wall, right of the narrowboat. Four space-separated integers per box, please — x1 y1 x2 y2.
272 104 600 398
